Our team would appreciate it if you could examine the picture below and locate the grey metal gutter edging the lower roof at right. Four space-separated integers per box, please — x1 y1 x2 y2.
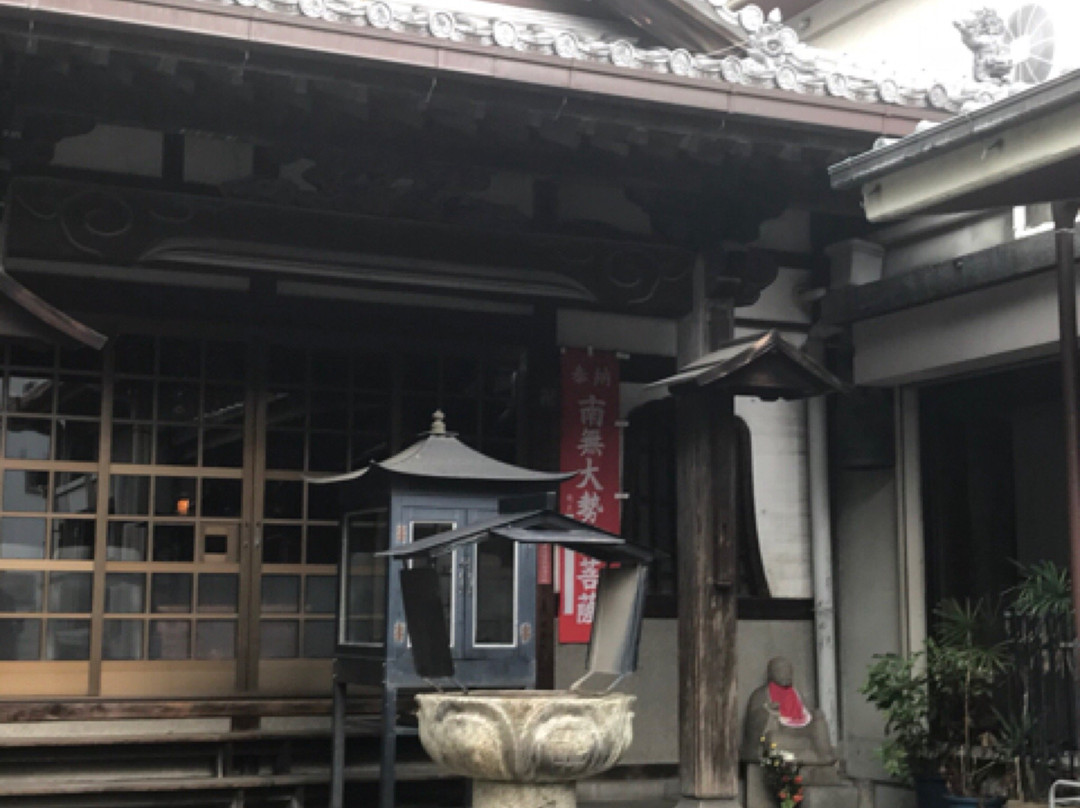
828 71 1080 190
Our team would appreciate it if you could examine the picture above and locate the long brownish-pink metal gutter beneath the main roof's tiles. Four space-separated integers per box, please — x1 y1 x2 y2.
0 0 935 137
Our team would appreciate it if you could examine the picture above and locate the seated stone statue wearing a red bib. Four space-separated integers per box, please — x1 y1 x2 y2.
740 657 837 766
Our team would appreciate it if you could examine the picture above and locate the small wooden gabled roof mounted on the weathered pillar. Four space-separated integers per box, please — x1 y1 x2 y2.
649 331 848 400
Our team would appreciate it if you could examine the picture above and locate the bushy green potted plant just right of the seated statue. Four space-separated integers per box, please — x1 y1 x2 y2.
862 601 1009 808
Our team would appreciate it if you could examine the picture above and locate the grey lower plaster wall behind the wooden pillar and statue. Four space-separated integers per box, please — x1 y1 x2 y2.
555 620 816 765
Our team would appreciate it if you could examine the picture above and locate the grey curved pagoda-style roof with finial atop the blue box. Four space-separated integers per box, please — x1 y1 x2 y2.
309 413 577 485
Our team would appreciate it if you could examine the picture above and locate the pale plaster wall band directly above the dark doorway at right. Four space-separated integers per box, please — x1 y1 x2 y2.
852 266 1057 386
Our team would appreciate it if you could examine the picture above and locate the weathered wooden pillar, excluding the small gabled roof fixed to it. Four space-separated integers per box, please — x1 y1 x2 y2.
676 256 739 808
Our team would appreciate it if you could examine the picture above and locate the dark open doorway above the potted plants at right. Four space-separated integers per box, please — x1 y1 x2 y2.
920 362 1068 606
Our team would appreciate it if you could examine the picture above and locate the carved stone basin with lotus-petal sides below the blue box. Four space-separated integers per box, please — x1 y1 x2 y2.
416 690 634 808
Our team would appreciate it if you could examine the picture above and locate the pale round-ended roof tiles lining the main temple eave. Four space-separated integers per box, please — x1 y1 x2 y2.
208 0 1010 112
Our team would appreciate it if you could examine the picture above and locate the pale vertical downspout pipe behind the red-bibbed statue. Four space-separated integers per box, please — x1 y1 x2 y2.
807 330 840 741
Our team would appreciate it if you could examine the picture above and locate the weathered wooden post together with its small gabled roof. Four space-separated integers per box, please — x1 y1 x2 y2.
656 321 845 808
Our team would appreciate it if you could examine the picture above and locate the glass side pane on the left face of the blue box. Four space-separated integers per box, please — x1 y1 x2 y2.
342 510 390 645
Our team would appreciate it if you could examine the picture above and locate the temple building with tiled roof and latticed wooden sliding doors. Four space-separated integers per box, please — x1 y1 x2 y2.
0 0 1036 806
